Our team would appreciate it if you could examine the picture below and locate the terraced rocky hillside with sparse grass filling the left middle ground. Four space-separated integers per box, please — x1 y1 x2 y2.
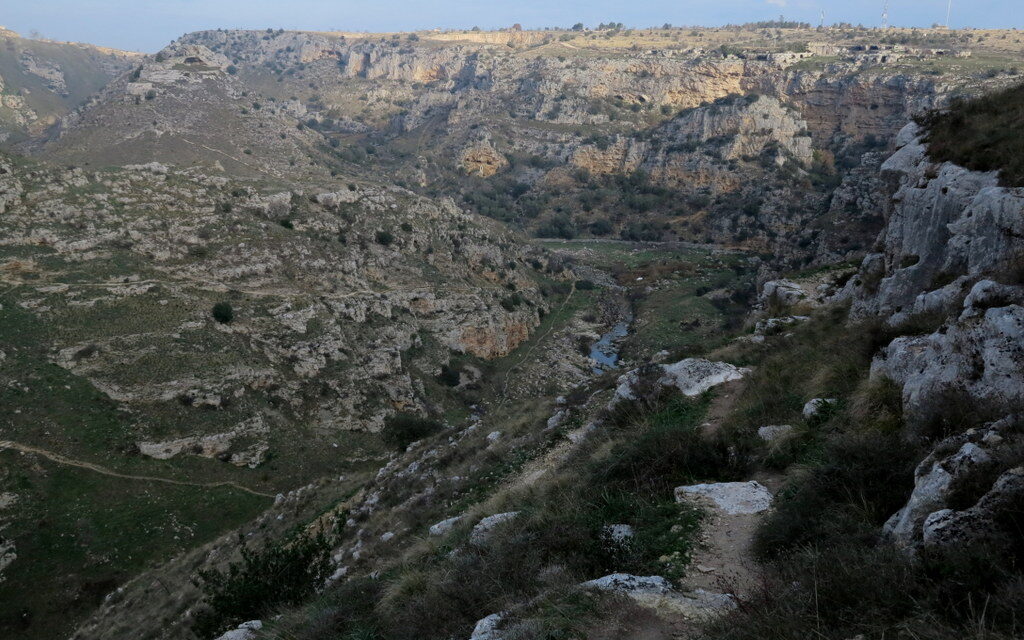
0 146 564 637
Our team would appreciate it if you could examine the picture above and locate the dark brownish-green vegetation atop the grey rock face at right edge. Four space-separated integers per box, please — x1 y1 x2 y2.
918 84 1024 186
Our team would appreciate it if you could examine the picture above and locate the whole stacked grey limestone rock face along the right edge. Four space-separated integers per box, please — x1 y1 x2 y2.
841 124 1024 546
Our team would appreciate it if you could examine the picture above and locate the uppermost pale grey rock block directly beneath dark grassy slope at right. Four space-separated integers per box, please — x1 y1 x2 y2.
848 124 1024 325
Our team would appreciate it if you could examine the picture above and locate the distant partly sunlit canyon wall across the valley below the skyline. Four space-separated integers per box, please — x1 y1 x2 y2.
14 30 1001 266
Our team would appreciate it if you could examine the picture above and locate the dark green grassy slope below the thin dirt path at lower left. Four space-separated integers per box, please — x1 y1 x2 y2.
0 452 270 640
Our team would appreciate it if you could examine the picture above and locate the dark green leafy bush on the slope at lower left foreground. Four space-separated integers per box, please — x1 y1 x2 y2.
194 532 333 638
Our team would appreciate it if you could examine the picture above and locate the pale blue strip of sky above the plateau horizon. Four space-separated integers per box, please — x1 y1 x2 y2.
0 0 1024 52
